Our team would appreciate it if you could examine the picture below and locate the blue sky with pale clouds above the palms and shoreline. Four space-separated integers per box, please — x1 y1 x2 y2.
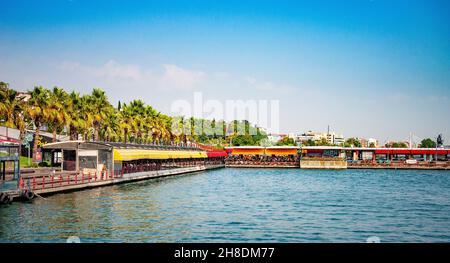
0 0 450 144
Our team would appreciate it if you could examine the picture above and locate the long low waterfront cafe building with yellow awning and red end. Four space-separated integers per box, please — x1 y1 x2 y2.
42 141 227 176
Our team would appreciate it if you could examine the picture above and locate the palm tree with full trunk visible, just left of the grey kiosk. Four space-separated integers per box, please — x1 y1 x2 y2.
27 86 50 161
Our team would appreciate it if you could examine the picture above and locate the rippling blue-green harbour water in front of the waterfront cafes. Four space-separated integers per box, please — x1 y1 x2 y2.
0 168 450 242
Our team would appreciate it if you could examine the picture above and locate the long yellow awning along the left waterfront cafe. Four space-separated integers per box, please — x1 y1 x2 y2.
114 149 208 161
